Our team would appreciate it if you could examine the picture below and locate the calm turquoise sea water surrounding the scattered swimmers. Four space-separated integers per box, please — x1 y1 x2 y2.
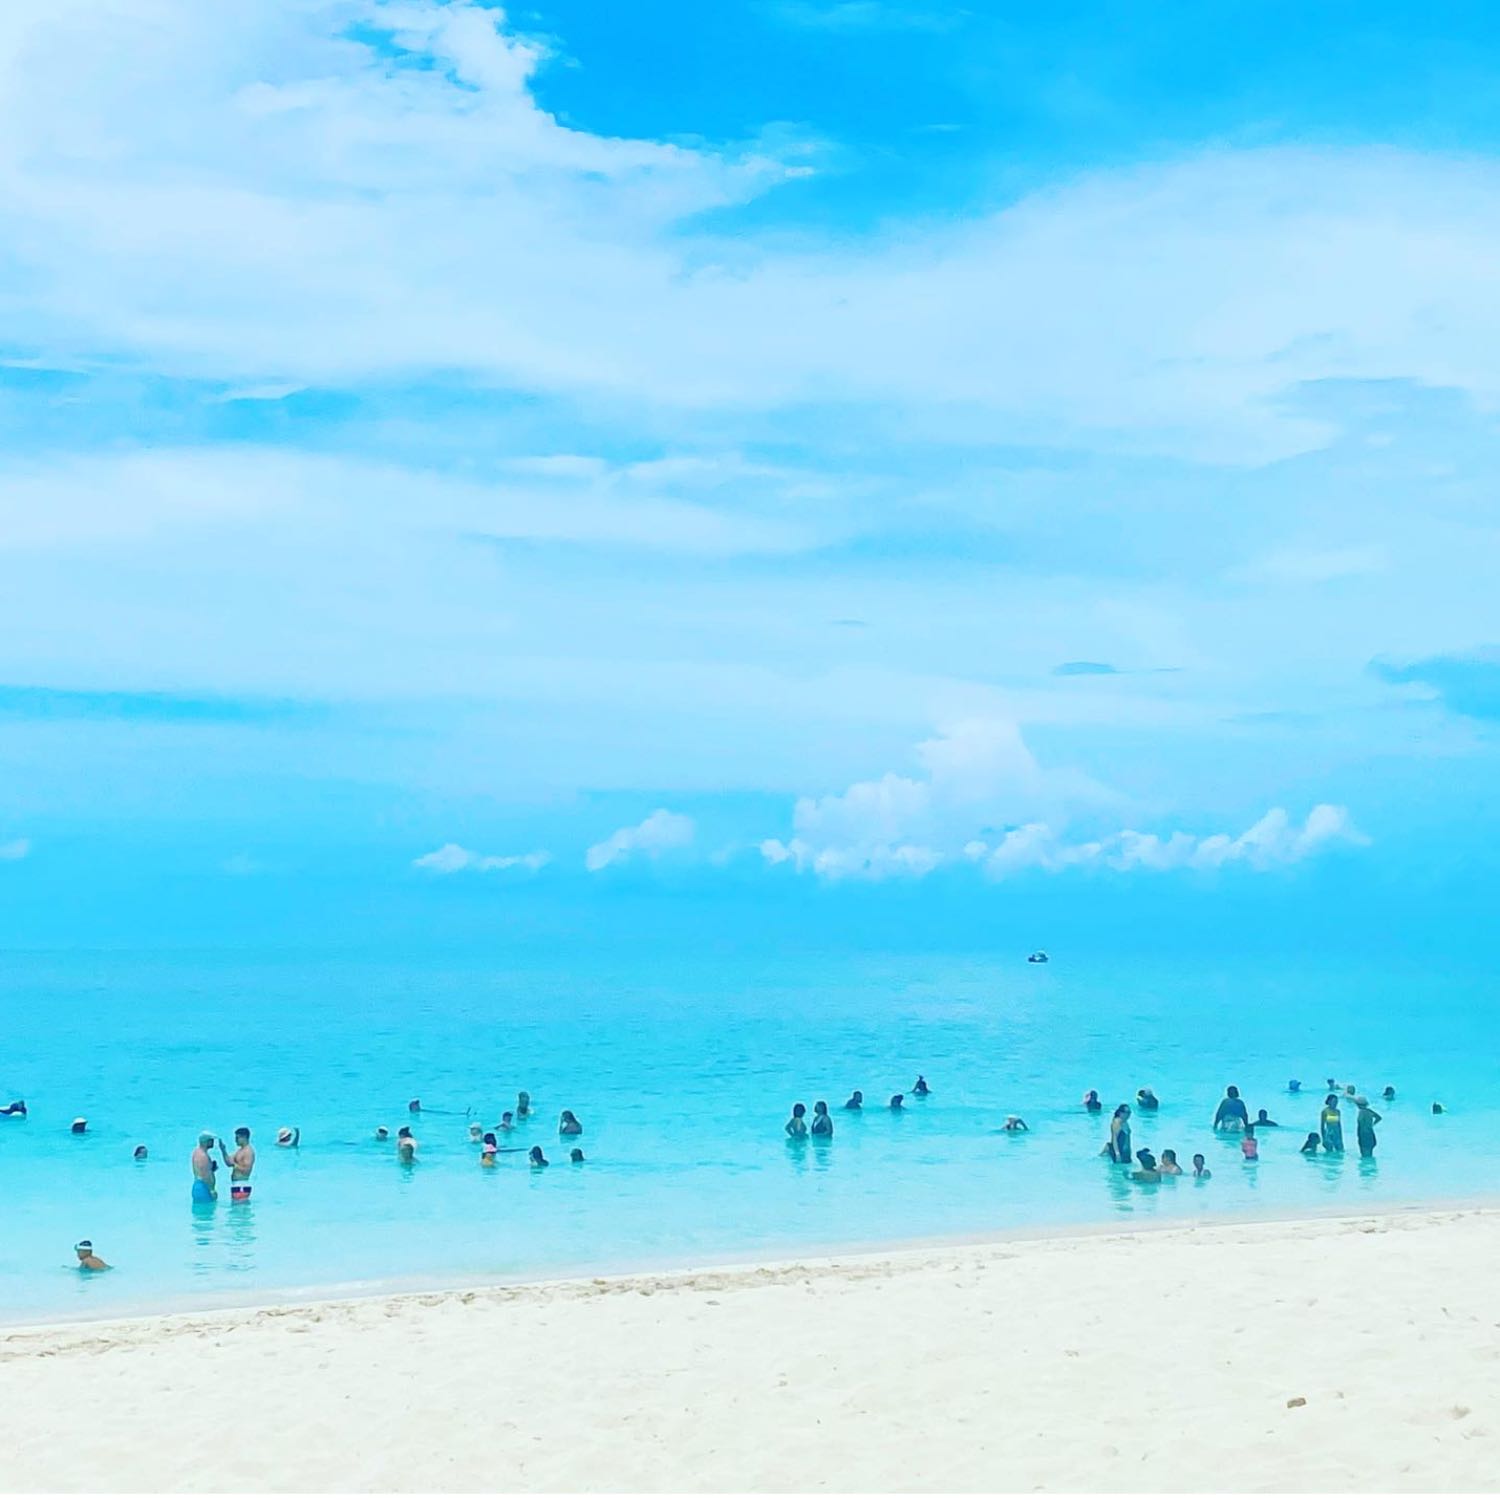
0 951 1500 1320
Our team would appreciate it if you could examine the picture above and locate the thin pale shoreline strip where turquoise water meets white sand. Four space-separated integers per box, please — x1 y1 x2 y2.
0 1194 1500 1338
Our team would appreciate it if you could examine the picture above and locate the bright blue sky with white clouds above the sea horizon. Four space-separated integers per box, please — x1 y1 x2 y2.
0 0 1500 942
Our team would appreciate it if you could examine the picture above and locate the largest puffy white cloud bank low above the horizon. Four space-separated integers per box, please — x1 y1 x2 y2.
759 720 1367 881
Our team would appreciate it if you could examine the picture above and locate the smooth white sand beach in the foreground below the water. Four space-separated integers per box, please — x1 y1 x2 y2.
0 1211 1500 1491
